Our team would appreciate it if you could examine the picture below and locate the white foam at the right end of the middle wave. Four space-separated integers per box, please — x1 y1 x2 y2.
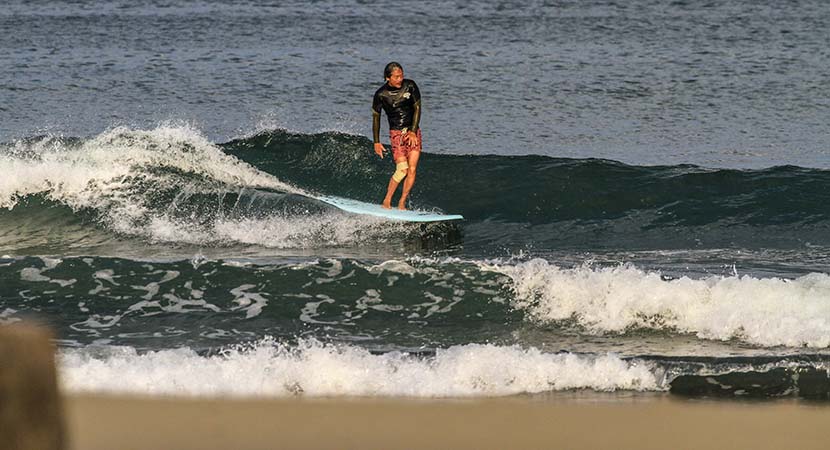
498 259 830 347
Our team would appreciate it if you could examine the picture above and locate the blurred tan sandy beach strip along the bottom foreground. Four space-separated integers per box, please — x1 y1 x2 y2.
64 394 830 450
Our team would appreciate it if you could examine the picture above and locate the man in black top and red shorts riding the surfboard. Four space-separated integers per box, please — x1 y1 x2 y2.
372 62 421 209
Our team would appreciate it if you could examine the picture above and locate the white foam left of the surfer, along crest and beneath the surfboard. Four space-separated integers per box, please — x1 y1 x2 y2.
0 126 410 248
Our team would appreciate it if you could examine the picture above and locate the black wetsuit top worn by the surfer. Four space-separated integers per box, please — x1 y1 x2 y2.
372 79 421 142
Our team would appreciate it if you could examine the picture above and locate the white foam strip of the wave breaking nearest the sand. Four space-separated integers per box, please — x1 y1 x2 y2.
59 339 662 397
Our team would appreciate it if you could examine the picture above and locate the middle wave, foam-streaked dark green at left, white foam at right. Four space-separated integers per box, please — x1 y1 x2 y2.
0 257 830 350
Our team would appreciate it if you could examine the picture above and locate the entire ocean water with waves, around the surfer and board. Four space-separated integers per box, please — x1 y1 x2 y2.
0 0 830 399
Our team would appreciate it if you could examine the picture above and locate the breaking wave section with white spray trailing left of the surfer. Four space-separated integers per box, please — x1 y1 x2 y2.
0 126 426 252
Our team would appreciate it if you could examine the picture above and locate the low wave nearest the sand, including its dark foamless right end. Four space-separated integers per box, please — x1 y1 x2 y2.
58 338 830 400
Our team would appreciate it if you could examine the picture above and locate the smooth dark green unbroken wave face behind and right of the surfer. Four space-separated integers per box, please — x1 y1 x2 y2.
222 130 830 248
